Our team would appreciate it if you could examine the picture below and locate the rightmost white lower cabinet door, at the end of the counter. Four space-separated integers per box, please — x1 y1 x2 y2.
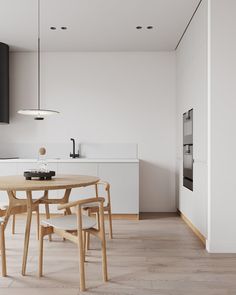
99 163 139 214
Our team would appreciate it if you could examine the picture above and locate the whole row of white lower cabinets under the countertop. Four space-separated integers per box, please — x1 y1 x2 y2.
0 160 139 214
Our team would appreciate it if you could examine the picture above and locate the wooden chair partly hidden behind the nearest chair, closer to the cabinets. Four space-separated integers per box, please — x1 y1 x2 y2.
84 181 113 250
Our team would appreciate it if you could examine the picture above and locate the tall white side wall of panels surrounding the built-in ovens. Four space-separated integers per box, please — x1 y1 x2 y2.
176 0 207 237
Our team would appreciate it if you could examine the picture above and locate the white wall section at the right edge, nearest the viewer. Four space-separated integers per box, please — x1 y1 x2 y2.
208 0 236 253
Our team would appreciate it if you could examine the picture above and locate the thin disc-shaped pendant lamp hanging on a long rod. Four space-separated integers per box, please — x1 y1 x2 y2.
18 0 59 120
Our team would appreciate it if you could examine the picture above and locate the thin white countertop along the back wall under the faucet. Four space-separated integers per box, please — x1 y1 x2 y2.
0 158 139 163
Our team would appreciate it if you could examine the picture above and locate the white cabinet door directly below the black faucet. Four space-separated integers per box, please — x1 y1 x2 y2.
58 162 97 201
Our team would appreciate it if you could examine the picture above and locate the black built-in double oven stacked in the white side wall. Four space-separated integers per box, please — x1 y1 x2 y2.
183 109 193 191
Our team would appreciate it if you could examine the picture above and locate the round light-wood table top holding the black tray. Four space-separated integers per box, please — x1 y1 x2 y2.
0 175 100 191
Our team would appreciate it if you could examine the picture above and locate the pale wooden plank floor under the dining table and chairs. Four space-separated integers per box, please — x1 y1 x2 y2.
0 214 236 295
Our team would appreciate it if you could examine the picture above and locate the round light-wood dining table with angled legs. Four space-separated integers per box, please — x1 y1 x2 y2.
0 175 100 275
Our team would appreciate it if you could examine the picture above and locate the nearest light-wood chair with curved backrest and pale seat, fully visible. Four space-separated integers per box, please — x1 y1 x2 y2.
39 197 108 291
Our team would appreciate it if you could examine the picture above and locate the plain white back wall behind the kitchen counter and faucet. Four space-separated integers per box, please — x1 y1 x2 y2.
0 52 176 211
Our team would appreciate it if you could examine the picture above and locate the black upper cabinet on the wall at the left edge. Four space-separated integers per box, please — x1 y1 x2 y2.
0 42 9 124
